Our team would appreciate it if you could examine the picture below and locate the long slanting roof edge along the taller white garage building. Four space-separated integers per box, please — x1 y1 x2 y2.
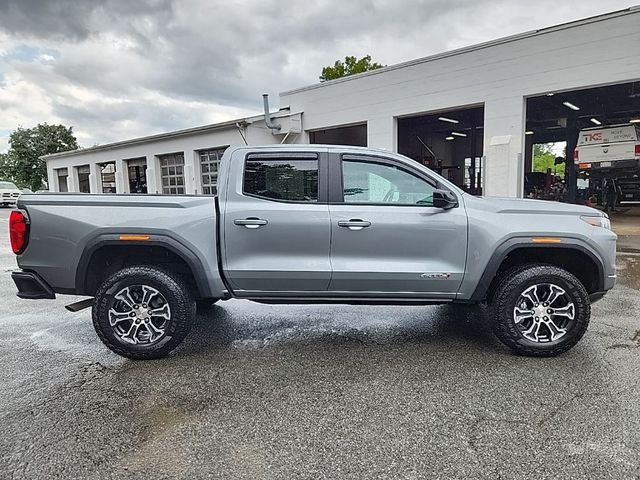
280 5 640 97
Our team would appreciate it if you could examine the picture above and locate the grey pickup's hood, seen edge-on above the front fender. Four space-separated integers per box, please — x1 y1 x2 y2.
476 197 604 217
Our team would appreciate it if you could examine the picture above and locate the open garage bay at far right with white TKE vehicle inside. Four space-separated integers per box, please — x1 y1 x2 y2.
524 82 640 205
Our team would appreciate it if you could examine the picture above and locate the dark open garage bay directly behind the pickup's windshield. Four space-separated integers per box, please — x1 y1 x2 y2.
398 106 484 195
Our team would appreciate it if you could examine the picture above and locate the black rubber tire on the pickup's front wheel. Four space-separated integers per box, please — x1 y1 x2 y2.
487 264 591 357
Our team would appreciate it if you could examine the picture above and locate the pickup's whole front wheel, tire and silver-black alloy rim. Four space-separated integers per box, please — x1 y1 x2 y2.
488 265 591 357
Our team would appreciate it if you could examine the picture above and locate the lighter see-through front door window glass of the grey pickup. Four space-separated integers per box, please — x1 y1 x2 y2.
342 160 436 207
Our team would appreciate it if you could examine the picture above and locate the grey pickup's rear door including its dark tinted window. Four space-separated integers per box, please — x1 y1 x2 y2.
221 151 331 297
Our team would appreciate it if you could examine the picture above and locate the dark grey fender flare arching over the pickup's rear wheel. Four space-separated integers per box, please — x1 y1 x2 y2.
75 231 214 298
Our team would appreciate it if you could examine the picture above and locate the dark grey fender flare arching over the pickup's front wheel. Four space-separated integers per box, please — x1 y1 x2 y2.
470 236 605 302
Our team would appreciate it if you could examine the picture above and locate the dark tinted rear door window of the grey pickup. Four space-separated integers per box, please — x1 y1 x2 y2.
243 158 318 202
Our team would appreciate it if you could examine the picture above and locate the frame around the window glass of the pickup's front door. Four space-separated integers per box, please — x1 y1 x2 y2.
329 153 452 208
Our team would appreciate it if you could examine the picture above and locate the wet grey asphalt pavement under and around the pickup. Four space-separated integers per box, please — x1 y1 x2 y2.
0 209 640 479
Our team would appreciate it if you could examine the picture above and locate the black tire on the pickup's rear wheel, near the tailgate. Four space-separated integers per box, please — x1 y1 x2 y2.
93 266 196 360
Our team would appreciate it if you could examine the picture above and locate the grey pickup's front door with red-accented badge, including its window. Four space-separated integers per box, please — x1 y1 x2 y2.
329 155 467 298
